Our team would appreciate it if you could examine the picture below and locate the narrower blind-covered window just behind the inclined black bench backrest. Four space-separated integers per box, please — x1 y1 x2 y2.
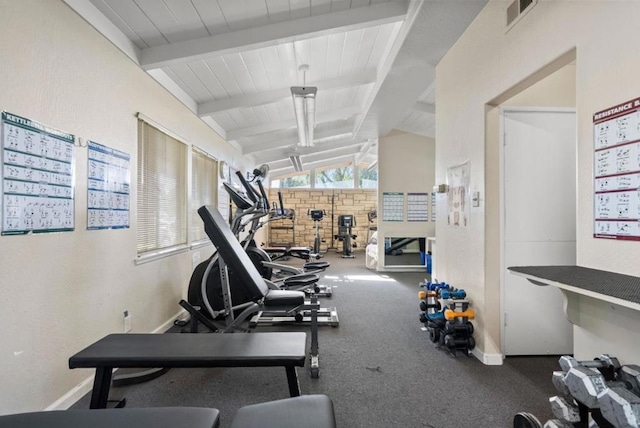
189 147 218 243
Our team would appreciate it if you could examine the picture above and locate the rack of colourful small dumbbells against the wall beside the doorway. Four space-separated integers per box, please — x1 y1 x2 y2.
419 282 475 356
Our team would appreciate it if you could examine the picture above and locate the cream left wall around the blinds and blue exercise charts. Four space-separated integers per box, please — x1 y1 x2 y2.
0 0 252 414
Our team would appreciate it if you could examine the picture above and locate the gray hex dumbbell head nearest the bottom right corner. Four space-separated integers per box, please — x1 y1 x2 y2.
598 386 640 428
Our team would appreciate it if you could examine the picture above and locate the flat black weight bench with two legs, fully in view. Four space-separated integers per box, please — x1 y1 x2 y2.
69 332 307 409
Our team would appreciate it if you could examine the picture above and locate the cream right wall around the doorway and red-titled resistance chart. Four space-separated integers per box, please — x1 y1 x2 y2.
435 0 640 362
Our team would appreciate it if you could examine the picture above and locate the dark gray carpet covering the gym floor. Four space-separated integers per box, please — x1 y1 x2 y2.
74 252 559 428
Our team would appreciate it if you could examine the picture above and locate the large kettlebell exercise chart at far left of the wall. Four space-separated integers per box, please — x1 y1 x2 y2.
1 112 75 235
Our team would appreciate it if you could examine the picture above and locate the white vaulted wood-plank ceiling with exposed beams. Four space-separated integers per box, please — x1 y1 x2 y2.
65 0 487 176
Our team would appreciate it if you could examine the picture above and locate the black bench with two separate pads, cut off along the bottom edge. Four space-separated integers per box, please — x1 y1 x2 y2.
0 395 336 428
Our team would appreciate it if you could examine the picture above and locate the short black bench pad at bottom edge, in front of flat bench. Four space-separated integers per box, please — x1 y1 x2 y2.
231 395 336 428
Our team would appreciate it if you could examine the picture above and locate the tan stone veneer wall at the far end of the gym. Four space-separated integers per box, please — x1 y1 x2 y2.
265 189 378 251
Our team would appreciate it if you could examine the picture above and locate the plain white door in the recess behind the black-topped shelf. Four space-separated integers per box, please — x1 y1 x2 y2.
502 109 576 356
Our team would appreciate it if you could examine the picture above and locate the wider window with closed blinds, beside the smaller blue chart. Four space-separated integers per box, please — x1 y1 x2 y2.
137 119 187 256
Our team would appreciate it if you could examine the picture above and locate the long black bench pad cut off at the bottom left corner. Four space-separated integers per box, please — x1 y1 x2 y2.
0 407 220 428
